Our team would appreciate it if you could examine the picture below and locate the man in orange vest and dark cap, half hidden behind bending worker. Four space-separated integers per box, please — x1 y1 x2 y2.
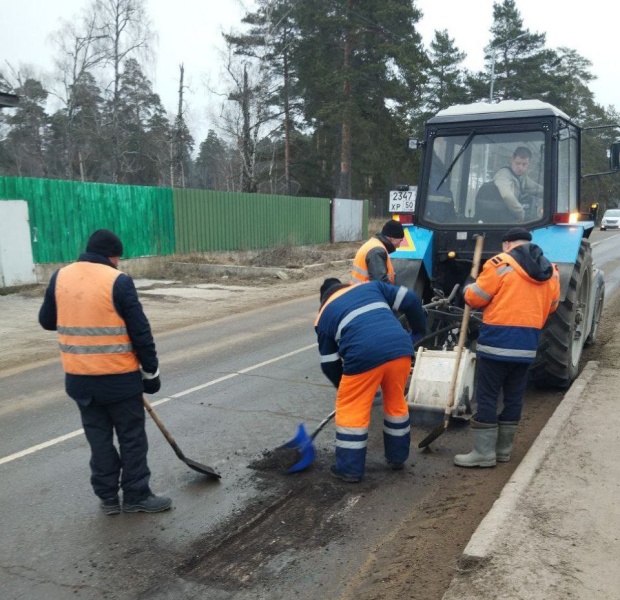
351 220 405 283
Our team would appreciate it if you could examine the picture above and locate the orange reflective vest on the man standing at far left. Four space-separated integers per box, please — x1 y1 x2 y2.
56 261 140 375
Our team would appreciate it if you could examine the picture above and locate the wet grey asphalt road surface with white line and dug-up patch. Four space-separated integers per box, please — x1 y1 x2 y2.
0 227 620 600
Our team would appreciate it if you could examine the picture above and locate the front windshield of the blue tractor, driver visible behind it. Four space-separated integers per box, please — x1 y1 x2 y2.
419 131 545 225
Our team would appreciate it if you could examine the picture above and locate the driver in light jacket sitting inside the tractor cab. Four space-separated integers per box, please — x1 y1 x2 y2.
493 146 543 222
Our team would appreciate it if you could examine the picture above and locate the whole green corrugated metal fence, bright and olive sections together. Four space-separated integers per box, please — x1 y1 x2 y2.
0 177 331 263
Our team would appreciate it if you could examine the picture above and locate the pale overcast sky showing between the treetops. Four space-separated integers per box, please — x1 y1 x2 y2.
0 0 620 141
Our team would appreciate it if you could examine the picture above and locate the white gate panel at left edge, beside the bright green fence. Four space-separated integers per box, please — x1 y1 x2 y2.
0 200 37 287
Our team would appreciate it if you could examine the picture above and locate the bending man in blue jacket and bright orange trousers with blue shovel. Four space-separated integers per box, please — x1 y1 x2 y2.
315 279 426 483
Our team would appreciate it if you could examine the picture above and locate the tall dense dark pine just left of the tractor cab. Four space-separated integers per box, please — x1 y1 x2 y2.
293 0 427 197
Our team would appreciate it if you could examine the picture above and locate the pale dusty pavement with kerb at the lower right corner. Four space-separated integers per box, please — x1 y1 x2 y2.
443 344 620 600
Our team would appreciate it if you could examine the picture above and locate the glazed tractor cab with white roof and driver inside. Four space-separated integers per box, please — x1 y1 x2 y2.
418 101 579 229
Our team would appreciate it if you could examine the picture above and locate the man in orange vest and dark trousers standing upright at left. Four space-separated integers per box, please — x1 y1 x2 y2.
39 229 172 515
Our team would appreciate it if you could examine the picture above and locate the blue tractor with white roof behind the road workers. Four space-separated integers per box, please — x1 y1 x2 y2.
390 100 620 388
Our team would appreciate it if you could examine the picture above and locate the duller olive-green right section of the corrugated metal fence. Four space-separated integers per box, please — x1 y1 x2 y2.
174 189 331 254
